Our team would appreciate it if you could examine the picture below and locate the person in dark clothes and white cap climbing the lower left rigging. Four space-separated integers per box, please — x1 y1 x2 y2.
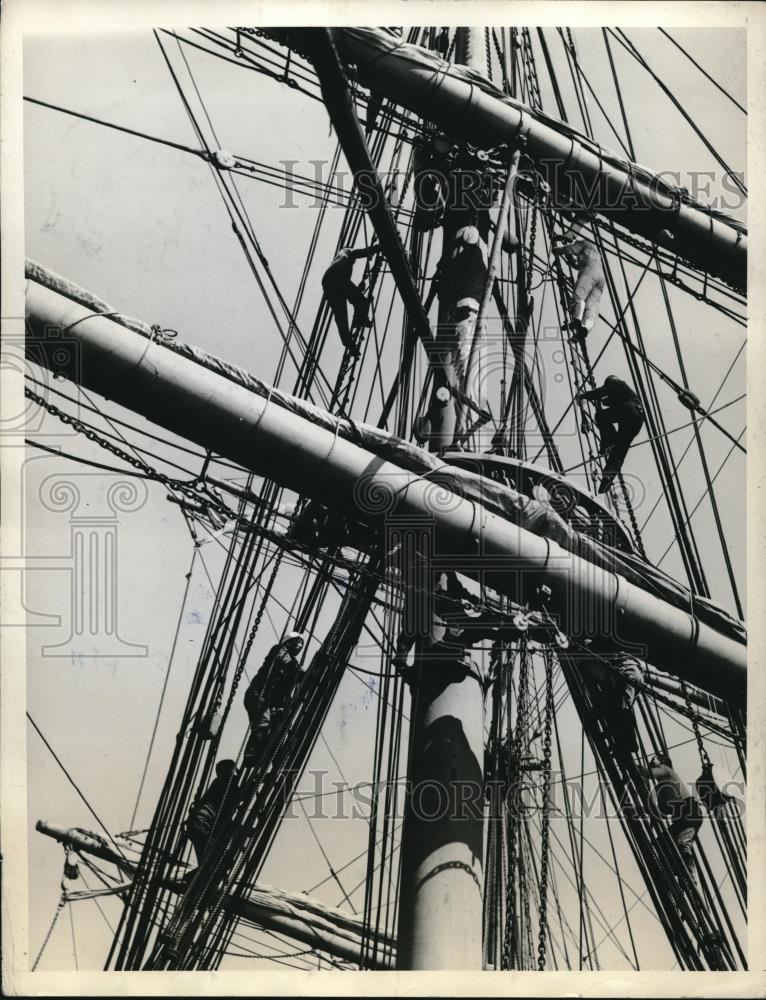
244 632 304 767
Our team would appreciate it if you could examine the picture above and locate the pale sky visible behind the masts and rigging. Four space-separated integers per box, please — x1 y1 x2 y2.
24 28 746 970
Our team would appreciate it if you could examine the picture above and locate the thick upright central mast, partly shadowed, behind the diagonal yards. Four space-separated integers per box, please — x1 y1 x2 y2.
397 28 488 970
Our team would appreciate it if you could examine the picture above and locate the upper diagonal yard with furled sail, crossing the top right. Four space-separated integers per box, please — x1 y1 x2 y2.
267 28 747 292
